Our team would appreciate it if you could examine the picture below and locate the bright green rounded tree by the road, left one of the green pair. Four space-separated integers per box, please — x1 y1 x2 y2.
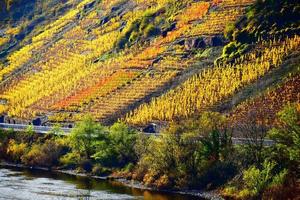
69 115 106 160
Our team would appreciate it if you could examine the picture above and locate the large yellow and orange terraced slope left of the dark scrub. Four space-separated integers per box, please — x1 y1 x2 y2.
1 0 253 125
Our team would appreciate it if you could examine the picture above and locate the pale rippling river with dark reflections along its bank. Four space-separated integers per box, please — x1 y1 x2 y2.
0 167 199 200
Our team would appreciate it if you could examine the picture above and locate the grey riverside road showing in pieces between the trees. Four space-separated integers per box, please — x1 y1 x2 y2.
0 123 275 146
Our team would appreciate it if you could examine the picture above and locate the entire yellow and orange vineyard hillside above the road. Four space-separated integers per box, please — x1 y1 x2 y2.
0 0 300 126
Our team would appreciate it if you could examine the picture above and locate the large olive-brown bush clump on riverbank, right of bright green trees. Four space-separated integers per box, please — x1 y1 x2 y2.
133 112 235 189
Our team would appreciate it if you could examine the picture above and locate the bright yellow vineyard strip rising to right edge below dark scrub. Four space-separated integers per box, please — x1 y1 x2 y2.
126 36 300 124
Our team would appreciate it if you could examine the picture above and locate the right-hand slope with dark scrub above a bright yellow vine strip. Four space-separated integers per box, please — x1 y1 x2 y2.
126 0 300 125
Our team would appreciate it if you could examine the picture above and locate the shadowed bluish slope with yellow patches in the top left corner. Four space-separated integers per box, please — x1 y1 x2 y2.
0 0 79 59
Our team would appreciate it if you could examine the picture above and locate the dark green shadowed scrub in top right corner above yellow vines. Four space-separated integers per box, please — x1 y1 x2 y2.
219 0 300 64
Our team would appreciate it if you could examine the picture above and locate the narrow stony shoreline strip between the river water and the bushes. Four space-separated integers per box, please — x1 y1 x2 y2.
0 160 223 200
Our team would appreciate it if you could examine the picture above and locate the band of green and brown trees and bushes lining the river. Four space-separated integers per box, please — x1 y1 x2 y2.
0 105 300 200
